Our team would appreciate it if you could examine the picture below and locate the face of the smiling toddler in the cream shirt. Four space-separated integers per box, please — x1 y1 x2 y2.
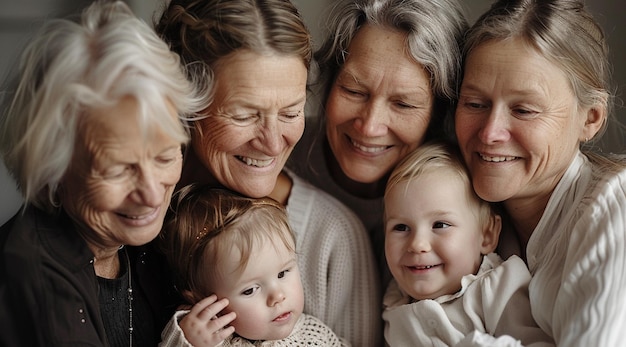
385 168 500 300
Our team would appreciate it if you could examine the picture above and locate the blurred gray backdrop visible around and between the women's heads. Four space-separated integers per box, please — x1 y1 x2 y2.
0 0 626 225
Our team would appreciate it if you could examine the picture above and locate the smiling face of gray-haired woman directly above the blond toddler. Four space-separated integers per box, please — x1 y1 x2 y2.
326 25 433 188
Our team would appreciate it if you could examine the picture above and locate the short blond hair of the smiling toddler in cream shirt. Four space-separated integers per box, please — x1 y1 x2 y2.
385 141 496 225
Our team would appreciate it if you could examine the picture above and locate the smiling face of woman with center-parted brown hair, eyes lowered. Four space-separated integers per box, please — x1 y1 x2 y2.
192 50 307 197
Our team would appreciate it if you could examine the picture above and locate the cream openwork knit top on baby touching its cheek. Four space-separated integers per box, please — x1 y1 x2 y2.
159 310 350 347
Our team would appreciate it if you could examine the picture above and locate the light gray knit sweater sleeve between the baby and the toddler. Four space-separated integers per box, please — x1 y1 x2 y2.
286 170 383 347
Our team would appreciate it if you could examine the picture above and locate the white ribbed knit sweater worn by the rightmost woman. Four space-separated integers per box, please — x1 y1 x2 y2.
494 153 626 347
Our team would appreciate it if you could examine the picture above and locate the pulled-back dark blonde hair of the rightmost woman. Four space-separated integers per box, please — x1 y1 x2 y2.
464 0 612 141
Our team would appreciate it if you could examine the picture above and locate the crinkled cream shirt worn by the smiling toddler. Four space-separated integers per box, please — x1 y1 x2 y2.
383 253 554 347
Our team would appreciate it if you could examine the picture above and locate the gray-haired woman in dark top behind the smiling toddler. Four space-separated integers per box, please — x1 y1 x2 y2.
288 0 467 277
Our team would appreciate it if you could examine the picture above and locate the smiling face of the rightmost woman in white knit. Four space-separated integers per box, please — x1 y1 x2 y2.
455 39 589 207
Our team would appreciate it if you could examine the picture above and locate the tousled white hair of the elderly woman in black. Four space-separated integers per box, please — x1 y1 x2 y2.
0 1 206 209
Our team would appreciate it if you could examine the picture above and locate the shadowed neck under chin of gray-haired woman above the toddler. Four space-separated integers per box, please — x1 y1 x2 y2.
324 142 388 199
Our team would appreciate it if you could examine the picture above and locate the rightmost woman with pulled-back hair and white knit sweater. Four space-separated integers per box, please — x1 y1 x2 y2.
455 0 626 347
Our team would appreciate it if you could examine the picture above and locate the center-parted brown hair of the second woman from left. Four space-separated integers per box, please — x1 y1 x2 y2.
155 0 312 108
